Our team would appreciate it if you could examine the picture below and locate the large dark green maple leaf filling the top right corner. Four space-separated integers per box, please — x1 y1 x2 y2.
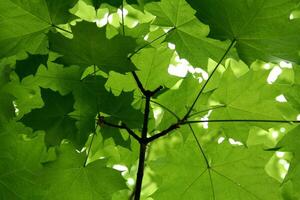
187 0 300 64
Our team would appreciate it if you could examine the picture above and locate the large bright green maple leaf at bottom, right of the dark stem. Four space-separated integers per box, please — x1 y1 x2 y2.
149 134 280 200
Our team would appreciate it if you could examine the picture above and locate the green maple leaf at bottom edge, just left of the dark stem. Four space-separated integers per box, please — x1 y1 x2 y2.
39 144 126 200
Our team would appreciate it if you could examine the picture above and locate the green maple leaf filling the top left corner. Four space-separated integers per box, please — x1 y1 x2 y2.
0 0 76 58
